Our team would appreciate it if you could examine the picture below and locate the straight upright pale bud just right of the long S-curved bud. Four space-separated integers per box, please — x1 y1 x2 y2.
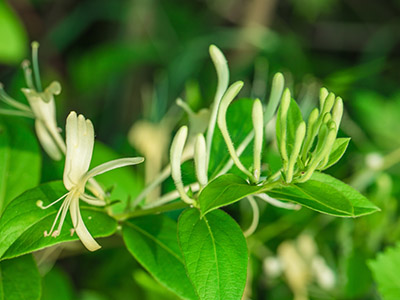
252 99 264 181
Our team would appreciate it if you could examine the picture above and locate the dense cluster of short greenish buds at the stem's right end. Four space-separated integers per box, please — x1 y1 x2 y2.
276 88 343 183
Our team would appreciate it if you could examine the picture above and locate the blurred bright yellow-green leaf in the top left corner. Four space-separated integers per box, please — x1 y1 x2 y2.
0 1 28 64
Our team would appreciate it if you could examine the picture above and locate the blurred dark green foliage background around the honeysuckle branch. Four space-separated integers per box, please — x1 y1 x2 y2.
0 0 400 300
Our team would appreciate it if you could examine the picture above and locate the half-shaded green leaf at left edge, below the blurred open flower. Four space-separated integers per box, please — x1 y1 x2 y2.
0 118 41 215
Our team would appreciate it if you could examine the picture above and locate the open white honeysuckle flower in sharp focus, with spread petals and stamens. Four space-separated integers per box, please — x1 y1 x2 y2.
37 112 144 251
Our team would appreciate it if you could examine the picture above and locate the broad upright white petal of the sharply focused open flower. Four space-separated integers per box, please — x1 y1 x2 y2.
64 111 94 190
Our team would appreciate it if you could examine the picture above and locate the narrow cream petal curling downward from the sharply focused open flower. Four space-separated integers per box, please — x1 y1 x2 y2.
69 196 101 251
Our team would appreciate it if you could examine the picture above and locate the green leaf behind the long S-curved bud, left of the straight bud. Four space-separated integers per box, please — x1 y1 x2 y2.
209 98 254 178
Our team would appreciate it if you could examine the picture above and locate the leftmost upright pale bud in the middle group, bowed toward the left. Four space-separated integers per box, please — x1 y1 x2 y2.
170 126 194 204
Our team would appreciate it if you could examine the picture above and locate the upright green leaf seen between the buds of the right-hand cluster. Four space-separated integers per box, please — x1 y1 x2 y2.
276 99 303 157
